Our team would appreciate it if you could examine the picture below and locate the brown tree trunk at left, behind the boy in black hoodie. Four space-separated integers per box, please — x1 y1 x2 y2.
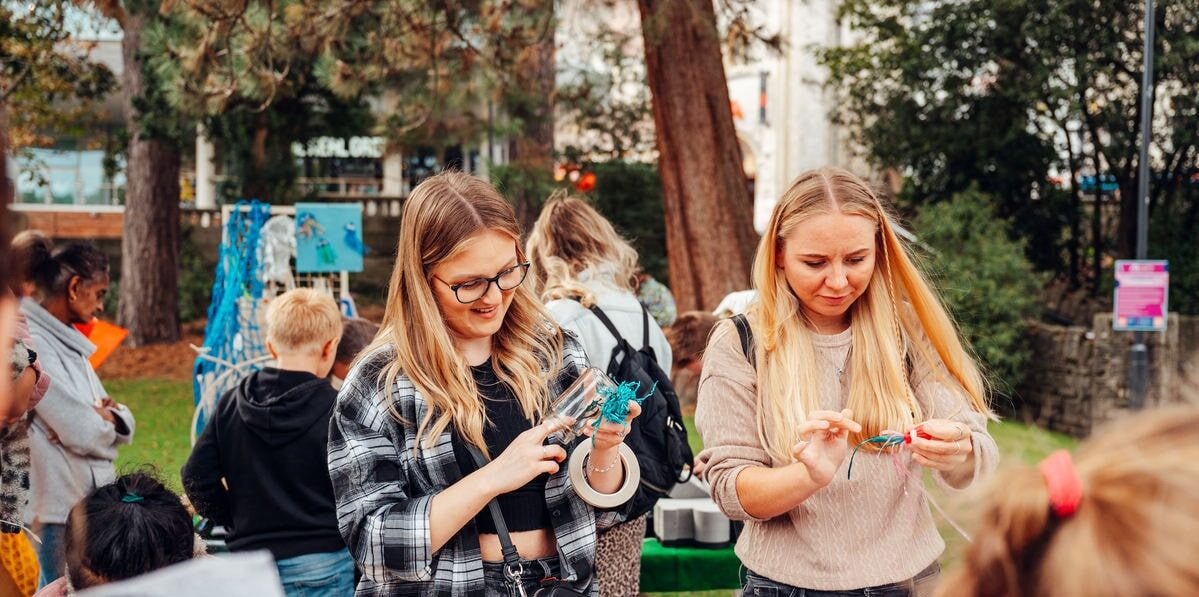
118 11 180 346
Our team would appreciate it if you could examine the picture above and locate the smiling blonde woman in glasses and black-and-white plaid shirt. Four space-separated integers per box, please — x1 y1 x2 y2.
329 173 639 596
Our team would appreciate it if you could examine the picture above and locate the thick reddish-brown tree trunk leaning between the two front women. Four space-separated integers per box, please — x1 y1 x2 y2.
638 0 758 312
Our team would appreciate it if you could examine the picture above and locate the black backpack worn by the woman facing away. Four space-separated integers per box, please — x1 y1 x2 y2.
590 306 694 520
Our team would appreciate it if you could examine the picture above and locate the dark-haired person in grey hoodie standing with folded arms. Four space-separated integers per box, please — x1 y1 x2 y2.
20 243 133 586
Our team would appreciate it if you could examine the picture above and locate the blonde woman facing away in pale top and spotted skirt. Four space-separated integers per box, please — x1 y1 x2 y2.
525 195 671 597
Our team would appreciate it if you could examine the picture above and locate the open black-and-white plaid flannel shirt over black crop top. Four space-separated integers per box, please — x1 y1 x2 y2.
329 333 621 597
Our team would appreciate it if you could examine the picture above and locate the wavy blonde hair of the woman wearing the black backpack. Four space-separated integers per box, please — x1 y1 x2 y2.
525 194 639 307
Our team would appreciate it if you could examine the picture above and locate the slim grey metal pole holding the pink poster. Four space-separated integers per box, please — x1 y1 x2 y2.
1128 0 1155 410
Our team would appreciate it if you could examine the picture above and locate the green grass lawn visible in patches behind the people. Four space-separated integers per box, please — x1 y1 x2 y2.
104 379 1078 597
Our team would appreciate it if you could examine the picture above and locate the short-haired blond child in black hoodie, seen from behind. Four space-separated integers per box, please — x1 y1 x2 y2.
183 289 354 596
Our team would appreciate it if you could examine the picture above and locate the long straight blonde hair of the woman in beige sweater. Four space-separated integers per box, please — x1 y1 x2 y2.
747 168 990 460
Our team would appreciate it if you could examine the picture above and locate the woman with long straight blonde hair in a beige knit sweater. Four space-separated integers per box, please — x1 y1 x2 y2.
695 169 998 596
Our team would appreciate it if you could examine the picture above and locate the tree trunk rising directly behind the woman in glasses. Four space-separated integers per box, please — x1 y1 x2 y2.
508 1 555 231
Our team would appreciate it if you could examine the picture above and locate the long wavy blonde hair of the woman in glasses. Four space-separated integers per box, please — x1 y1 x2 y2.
363 171 562 453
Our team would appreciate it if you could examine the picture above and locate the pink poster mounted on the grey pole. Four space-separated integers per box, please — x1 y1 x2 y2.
1111 259 1170 332
